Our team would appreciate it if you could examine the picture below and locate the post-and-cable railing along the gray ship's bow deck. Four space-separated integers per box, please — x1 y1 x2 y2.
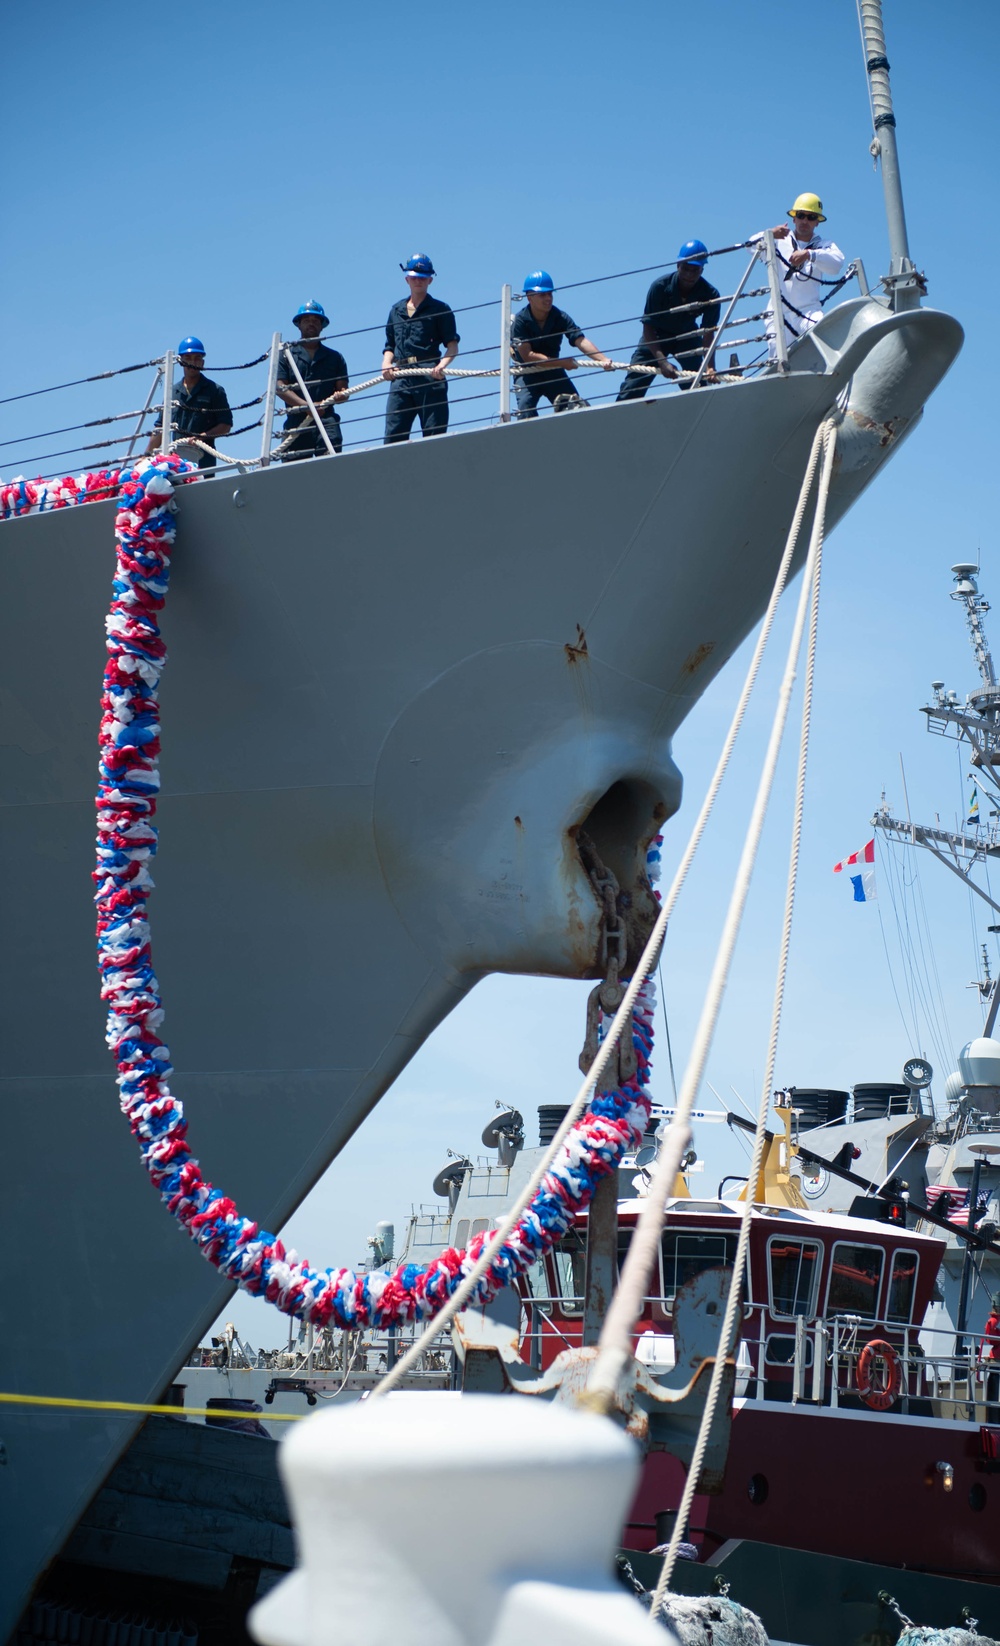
0 240 868 497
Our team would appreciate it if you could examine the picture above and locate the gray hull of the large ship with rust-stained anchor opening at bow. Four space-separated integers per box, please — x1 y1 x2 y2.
0 301 961 1628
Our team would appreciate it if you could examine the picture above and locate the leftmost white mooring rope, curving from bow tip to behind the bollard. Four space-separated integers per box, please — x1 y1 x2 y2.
370 414 832 1399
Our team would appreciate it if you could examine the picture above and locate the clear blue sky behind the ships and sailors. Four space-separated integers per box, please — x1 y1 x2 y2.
0 0 1000 1341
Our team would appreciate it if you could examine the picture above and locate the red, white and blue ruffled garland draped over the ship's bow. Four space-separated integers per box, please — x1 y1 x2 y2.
17 456 660 1328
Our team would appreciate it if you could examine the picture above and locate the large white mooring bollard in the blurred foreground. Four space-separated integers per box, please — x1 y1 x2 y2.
248 1391 671 1646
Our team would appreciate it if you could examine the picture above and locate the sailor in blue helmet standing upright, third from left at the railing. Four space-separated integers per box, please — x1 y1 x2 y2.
382 252 459 446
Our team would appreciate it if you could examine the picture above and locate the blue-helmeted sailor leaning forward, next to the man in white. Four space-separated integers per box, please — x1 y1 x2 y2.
618 240 719 400
